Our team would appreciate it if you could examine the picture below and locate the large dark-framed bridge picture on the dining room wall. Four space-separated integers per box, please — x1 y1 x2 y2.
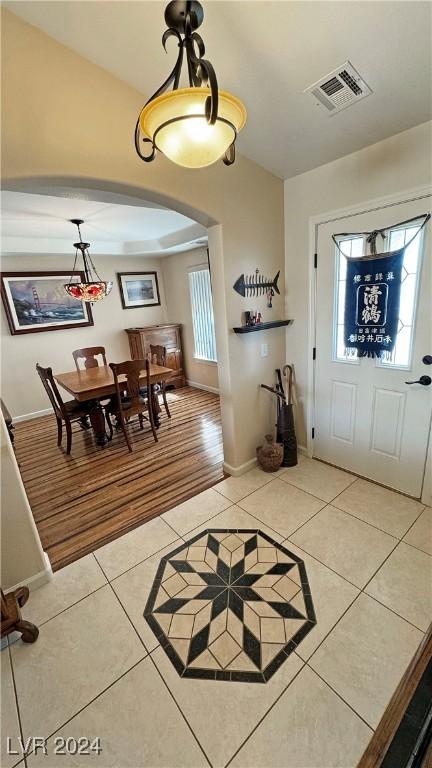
1 271 93 336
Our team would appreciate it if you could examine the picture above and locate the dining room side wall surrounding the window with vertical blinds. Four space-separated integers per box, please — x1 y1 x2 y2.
163 248 219 389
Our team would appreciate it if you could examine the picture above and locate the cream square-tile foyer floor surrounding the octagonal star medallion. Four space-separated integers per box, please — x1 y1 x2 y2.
0 457 432 768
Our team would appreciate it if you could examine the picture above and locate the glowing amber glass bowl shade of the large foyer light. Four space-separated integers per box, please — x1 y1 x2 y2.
140 88 246 168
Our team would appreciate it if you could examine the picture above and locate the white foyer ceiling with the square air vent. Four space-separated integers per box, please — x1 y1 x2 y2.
4 0 432 178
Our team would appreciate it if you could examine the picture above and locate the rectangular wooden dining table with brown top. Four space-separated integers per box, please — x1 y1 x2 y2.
54 363 172 445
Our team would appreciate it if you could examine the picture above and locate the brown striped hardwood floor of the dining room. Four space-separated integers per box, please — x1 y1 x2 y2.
15 387 223 570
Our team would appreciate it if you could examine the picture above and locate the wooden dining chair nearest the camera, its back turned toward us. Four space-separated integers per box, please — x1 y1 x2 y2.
105 360 158 453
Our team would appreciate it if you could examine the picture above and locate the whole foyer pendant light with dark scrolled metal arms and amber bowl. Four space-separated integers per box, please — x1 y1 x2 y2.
135 0 246 168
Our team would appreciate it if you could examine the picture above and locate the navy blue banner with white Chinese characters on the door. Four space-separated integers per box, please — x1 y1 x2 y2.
344 248 405 358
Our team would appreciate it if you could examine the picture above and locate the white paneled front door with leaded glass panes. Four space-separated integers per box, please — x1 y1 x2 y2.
313 197 432 498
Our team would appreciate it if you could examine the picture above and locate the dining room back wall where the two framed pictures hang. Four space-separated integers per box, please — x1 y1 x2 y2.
1 254 166 417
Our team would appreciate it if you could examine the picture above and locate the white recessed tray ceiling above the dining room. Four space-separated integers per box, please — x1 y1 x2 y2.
1 192 207 257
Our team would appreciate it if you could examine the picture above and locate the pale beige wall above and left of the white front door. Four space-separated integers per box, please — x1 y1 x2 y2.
285 123 432 445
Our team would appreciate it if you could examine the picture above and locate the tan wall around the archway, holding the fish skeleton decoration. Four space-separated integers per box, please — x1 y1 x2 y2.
2 11 285 467
